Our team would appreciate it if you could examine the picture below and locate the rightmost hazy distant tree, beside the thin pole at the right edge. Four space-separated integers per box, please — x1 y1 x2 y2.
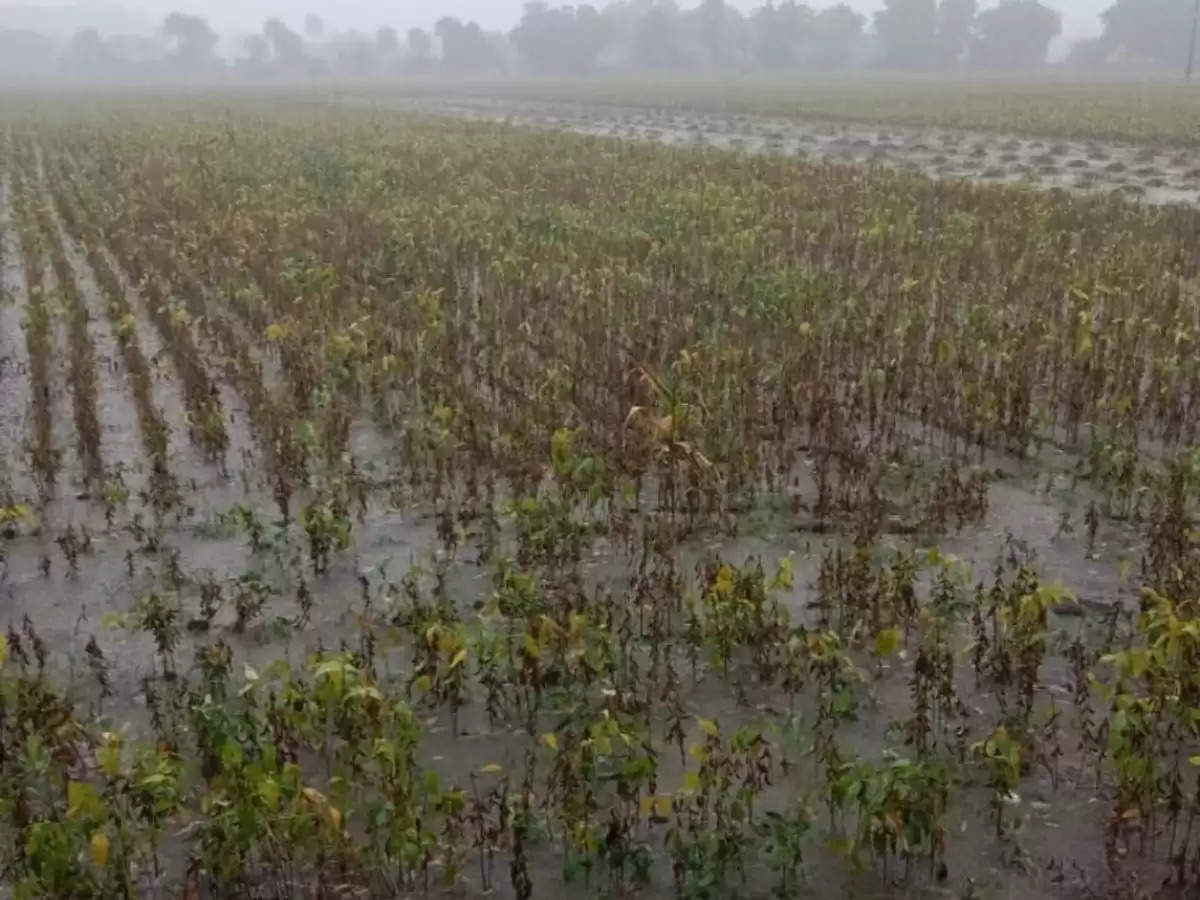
1096 0 1195 68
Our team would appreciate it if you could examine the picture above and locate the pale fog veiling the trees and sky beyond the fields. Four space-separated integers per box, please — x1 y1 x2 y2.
0 0 1194 82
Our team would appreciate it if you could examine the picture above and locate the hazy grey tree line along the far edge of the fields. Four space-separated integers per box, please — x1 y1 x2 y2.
0 0 1194 79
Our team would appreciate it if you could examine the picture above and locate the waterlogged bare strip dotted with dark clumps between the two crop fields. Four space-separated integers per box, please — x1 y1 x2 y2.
360 97 1200 205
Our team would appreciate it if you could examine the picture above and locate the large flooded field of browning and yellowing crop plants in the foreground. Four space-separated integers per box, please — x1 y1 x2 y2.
0 94 1200 900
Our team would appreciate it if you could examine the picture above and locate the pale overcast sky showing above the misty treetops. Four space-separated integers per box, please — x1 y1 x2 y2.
0 0 1112 37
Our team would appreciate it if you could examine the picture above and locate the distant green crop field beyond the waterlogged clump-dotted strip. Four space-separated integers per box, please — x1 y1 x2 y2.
355 74 1200 148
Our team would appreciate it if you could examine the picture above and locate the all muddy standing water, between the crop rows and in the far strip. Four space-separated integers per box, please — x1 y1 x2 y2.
0 121 1171 900
